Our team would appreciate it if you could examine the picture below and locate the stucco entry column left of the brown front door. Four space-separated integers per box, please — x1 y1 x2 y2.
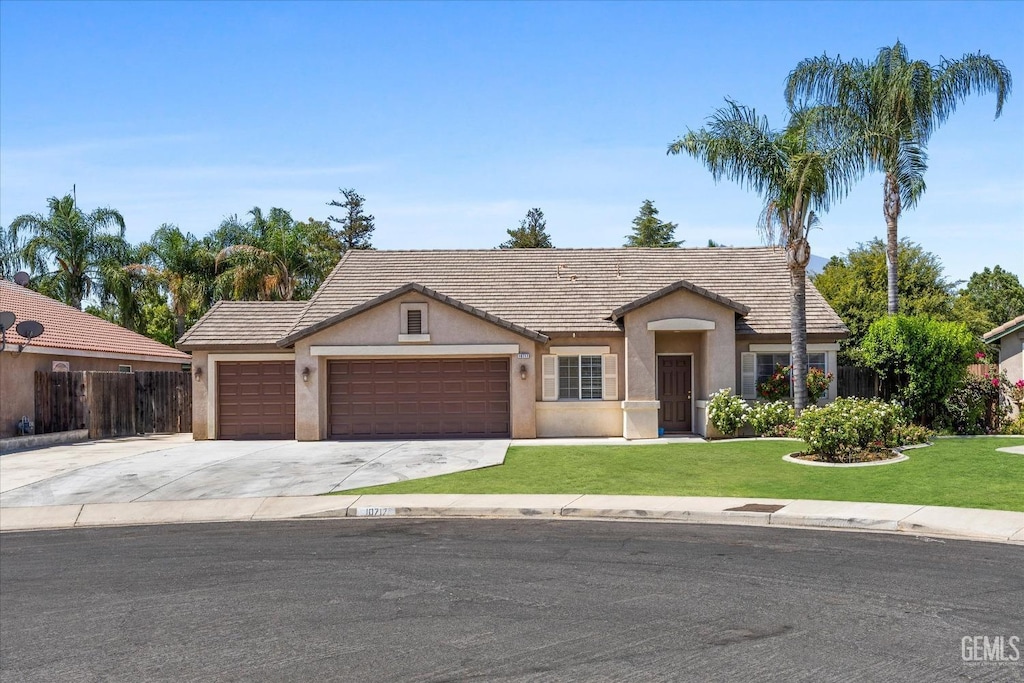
623 314 660 439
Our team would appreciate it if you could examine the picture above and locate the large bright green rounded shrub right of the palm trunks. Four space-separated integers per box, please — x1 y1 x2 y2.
860 315 978 424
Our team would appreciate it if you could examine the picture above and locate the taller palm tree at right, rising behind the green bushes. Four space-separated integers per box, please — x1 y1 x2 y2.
785 41 1013 314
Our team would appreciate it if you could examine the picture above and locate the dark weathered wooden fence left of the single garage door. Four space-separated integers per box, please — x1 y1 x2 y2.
36 371 191 438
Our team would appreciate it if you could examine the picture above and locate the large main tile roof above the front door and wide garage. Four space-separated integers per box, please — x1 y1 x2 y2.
291 247 847 335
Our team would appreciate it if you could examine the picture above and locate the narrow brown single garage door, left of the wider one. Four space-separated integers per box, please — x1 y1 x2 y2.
217 360 295 438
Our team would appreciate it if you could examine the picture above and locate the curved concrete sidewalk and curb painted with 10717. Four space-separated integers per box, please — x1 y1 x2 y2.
0 494 1024 545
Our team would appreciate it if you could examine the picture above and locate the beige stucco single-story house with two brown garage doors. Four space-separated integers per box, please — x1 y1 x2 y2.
178 248 847 440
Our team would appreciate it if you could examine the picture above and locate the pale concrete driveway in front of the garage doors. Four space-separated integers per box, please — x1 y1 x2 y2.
0 434 509 507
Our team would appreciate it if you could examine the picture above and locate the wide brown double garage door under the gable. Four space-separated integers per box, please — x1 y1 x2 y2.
328 358 511 438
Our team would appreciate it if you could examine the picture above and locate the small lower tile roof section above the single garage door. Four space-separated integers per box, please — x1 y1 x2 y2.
177 301 308 349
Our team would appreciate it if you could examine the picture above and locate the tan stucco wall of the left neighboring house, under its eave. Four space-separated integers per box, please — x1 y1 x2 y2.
0 347 187 436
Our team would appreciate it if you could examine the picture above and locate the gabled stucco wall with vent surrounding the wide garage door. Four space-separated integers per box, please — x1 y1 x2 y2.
295 293 538 441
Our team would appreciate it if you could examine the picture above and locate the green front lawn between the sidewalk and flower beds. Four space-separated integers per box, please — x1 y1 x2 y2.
339 437 1024 511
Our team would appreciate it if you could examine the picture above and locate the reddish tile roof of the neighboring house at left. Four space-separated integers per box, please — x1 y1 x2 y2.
0 280 191 361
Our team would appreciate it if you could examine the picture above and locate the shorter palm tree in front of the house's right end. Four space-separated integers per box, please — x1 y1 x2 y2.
669 99 864 415
